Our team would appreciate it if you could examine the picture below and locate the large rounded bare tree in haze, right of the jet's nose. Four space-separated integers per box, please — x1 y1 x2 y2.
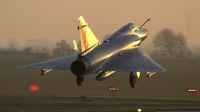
151 28 192 58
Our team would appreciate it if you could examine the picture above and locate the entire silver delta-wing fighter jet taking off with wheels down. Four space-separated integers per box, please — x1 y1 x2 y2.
22 16 165 88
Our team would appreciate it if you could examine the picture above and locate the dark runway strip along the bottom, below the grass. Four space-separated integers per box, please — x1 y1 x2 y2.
0 96 200 112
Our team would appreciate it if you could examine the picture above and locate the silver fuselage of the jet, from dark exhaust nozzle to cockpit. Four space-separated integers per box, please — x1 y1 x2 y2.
71 23 148 76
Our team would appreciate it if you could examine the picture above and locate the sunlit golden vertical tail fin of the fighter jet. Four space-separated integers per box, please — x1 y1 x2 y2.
78 16 99 52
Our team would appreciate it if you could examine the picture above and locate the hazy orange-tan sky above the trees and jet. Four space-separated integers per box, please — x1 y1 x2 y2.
0 0 200 46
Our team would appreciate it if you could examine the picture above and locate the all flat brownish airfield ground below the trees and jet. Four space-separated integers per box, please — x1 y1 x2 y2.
0 58 200 112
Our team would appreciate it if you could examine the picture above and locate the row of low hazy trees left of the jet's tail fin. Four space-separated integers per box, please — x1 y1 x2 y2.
0 40 80 58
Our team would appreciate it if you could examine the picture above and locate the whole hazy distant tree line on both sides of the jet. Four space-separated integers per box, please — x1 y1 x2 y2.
0 28 200 58
